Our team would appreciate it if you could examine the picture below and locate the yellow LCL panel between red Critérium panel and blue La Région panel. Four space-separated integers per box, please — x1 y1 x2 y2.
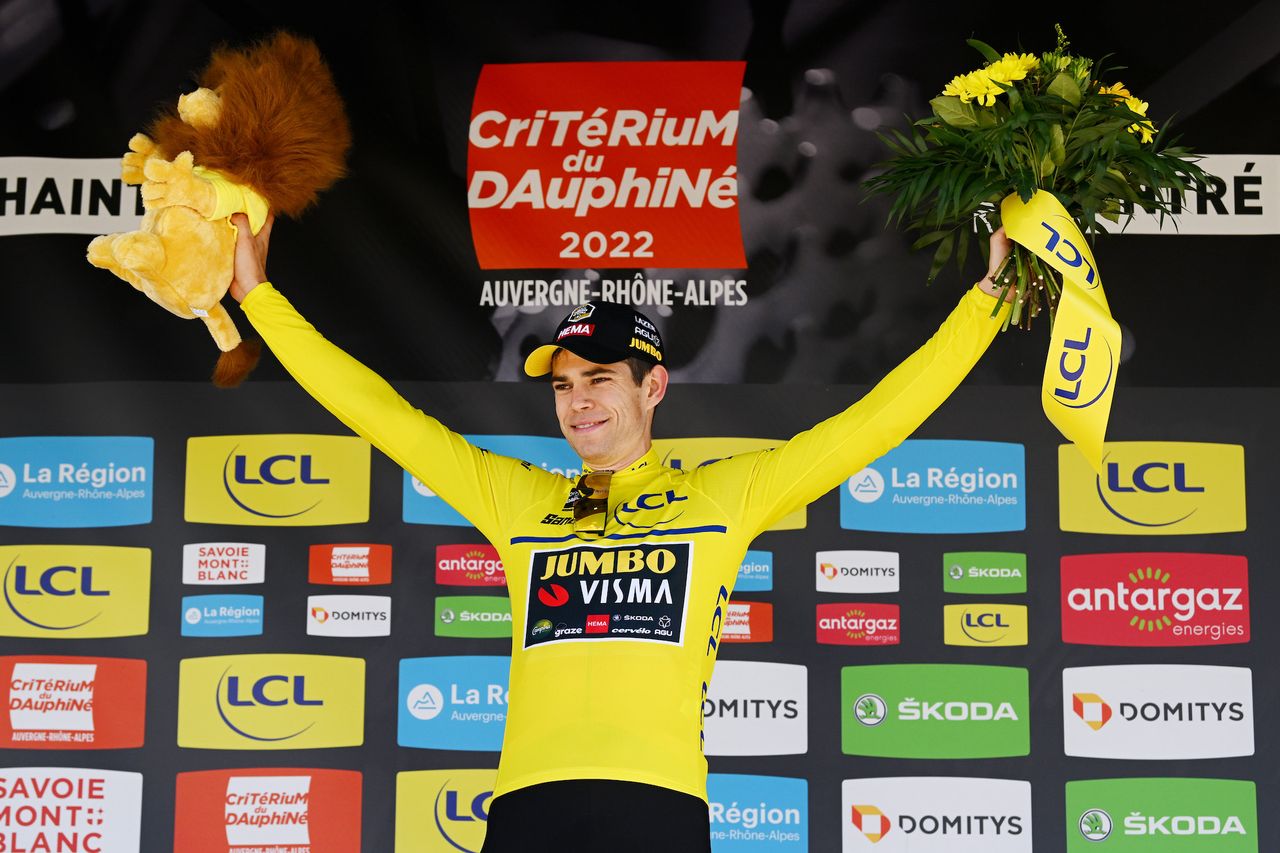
178 654 365 749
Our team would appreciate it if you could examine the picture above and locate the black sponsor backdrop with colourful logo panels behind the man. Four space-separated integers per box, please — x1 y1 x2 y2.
0 0 1280 853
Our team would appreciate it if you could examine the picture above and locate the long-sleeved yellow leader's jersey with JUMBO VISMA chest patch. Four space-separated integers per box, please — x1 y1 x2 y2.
243 284 1000 799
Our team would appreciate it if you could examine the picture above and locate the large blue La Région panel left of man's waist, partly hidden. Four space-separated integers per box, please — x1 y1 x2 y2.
396 656 511 751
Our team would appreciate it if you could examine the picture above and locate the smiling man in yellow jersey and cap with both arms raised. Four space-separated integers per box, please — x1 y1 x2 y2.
232 208 1009 853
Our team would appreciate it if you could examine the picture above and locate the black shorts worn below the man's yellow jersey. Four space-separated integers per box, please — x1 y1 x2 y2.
481 779 712 853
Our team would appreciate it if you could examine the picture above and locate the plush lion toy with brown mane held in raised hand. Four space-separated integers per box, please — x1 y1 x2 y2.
88 32 351 388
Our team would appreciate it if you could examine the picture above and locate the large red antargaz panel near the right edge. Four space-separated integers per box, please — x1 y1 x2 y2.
1062 553 1249 646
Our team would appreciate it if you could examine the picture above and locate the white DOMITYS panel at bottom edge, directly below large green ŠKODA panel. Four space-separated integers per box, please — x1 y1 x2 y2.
840 776 1032 853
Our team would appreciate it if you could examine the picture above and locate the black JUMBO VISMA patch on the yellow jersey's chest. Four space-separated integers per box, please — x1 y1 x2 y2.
524 542 694 648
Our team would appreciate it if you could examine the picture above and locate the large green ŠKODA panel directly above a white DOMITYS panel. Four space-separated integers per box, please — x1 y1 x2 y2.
840 663 1030 758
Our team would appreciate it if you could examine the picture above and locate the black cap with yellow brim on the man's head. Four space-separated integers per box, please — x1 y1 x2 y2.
525 302 663 377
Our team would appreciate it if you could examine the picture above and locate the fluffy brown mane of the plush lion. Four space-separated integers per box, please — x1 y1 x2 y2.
148 32 351 216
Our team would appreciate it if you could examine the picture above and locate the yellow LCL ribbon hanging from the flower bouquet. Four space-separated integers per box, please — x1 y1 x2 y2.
1000 190 1120 474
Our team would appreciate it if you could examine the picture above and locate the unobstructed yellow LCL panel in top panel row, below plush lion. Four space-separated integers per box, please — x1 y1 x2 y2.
186 434 370 526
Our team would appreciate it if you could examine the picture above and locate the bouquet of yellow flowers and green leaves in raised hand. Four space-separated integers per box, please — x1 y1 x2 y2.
864 27 1210 328
